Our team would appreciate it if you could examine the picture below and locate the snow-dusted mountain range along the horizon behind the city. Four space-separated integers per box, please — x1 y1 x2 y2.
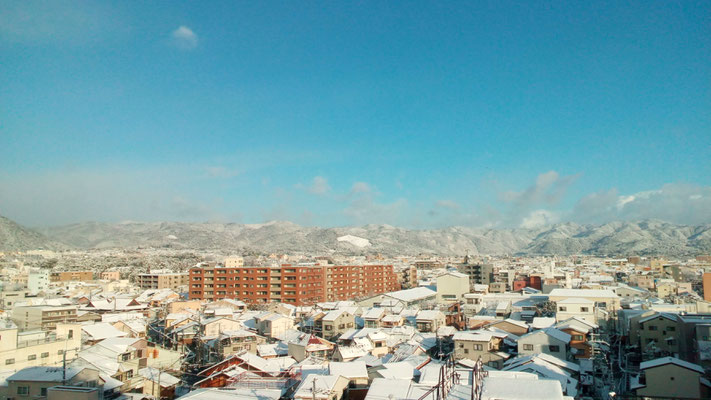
0 217 711 256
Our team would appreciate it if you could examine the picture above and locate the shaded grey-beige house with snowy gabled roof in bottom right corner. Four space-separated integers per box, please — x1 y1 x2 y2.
631 357 711 399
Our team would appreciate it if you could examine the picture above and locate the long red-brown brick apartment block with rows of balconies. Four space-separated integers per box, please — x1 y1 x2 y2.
189 264 400 305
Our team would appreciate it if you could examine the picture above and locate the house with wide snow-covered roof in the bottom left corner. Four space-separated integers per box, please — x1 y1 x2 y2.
6 367 104 399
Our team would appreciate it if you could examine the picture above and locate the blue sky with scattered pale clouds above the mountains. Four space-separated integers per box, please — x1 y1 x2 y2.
0 0 711 229
